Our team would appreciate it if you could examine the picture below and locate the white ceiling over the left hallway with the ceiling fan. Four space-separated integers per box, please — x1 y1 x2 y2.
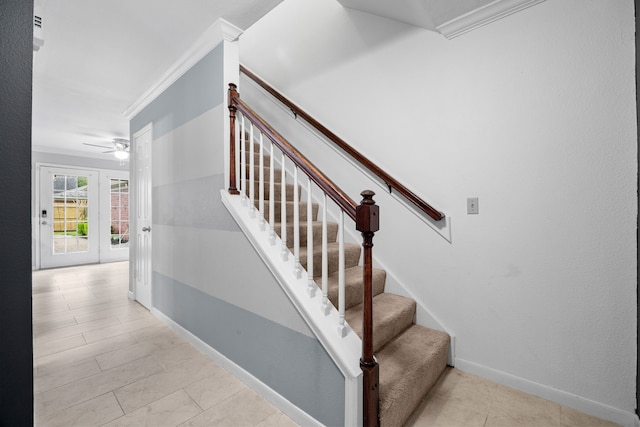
32 0 282 156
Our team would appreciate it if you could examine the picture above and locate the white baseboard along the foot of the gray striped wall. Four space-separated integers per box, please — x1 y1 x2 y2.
151 308 322 426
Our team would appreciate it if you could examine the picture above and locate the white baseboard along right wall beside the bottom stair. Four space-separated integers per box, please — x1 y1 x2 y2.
455 358 640 427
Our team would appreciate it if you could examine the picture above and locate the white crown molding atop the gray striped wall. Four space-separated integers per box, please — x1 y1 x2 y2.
122 18 243 120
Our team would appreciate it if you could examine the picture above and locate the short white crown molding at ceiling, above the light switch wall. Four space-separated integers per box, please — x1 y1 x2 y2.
436 0 544 39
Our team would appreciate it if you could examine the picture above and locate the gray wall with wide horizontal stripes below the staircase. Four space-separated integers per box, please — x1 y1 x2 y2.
130 44 345 425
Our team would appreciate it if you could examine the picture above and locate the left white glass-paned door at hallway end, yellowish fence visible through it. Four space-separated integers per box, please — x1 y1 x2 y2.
39 166 100 268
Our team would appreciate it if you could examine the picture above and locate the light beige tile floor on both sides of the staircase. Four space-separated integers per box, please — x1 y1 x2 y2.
33 262 614 427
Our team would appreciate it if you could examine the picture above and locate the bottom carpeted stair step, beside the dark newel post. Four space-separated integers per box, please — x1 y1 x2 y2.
376 325 449 427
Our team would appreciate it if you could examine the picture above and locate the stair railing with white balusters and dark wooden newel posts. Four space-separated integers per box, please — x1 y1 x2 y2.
228 83 380 426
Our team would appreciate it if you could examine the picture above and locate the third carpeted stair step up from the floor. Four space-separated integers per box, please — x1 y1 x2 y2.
324 265 387 309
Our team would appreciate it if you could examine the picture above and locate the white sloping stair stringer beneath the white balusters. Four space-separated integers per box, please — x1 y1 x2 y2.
220 190 362 426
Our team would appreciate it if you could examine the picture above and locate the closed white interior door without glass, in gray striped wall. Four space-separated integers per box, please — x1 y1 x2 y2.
133 125 152 308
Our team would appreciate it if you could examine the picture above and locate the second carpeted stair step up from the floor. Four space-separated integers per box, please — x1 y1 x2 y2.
345 293 416 353
